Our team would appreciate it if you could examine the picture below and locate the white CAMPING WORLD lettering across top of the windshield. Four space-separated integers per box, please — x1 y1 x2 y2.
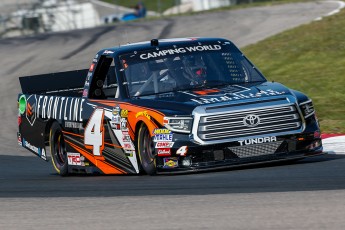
140 45 222 60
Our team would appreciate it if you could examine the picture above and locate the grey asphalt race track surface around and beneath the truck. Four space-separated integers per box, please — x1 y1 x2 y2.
0 2 345 229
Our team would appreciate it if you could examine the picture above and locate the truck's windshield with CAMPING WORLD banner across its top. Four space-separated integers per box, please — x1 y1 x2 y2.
120 42 266 97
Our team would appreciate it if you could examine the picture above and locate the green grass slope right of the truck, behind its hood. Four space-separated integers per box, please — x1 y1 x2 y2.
242 10 345 133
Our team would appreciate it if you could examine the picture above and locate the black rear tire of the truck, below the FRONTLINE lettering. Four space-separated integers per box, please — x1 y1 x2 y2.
49 122 68 176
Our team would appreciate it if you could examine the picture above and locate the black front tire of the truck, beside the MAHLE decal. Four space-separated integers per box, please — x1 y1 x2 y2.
137 123 157 175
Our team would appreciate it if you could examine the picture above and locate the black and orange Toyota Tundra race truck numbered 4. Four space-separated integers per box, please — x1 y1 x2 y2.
17 38 323 176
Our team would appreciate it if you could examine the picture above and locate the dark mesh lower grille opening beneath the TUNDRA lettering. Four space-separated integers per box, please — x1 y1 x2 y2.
228 141 283 158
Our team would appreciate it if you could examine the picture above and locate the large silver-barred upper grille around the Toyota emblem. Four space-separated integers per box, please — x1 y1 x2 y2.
198 105 302 141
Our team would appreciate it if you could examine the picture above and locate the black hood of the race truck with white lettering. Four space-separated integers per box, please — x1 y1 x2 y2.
131 82 293 116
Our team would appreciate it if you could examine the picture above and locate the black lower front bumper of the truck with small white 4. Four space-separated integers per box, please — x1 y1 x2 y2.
156 133 324 173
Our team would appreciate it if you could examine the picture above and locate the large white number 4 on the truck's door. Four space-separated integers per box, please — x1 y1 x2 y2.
84 108 104 156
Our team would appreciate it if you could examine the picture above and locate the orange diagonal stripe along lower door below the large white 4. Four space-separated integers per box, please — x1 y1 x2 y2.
65 140 126 174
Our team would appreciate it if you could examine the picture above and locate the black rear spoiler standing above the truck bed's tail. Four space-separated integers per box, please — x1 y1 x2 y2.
19 69 89 94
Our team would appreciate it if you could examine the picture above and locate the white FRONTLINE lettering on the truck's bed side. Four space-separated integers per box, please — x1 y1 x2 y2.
36 96 85 122
